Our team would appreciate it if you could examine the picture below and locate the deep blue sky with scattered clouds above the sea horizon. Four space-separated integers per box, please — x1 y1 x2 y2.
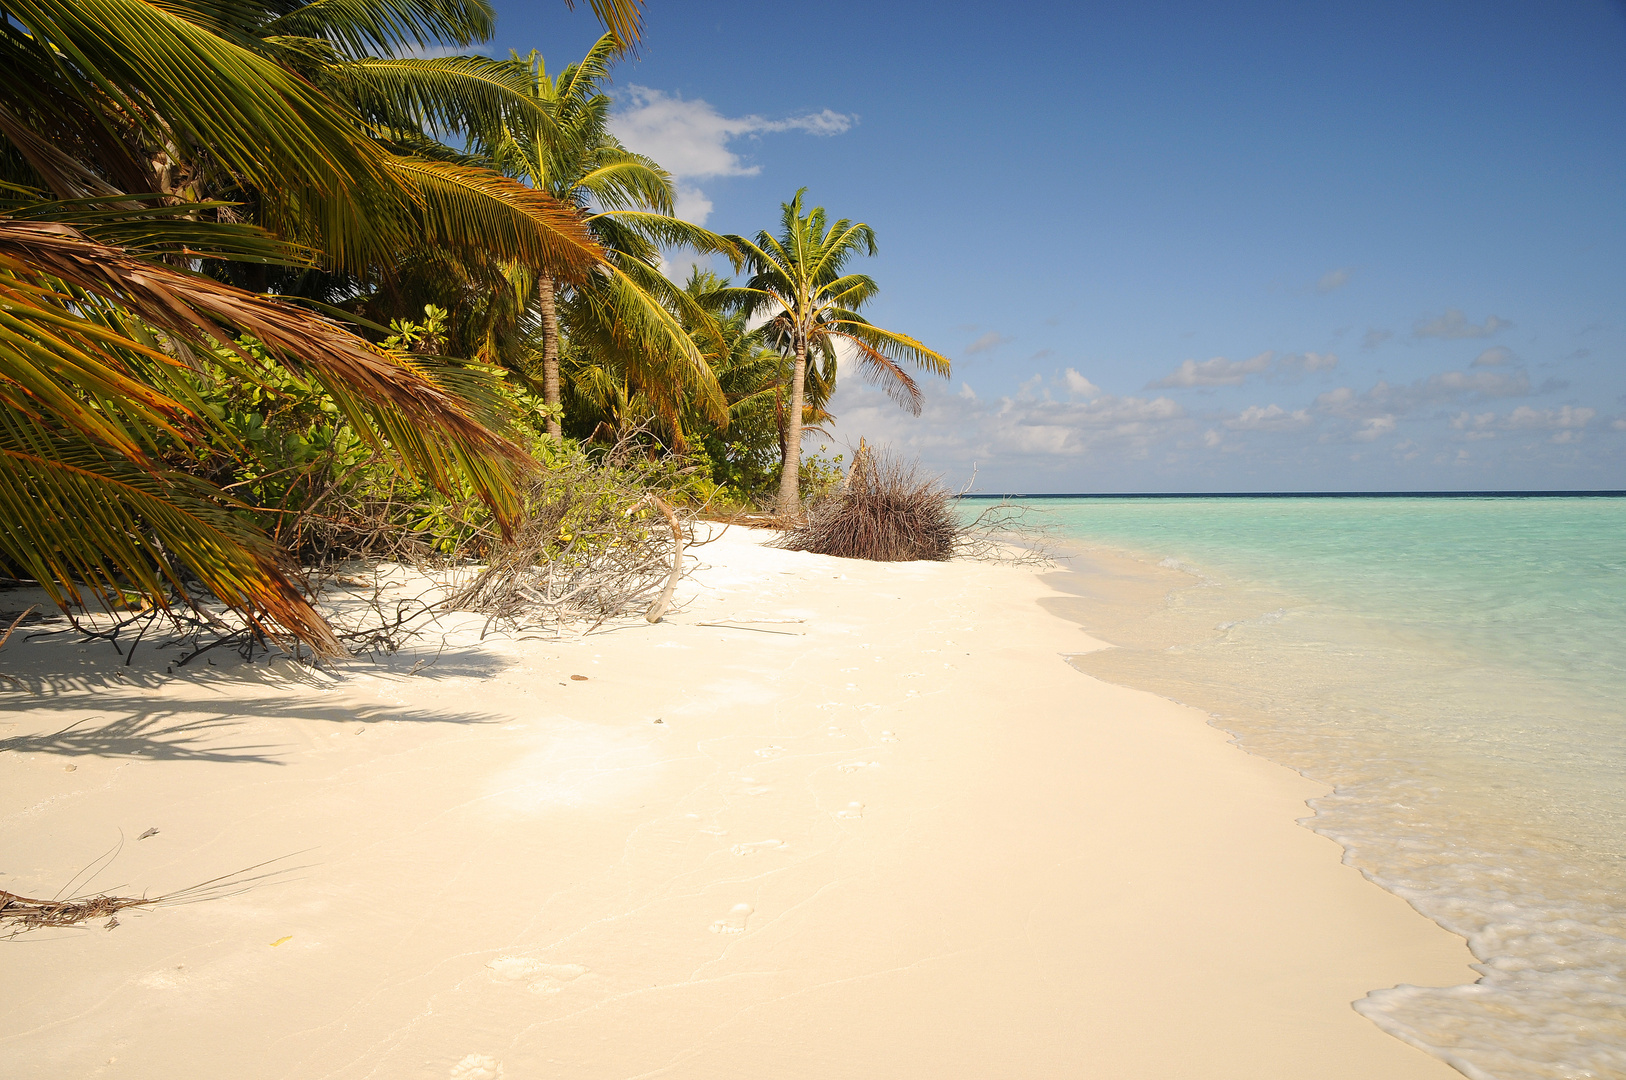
493 0 1626 491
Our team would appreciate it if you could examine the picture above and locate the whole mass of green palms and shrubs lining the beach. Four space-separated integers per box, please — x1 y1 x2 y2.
0 0 948 655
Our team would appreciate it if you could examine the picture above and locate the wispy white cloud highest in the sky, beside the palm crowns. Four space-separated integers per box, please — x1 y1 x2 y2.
610 86 857 224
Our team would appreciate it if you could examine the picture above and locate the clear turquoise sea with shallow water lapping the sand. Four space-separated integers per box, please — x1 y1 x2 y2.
1020 496 1626 1080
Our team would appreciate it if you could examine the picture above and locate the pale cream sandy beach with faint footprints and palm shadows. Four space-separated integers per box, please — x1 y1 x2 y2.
0 529 1473 1080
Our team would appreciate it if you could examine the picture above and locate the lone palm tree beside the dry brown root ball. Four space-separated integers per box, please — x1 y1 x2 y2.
724 187 948 517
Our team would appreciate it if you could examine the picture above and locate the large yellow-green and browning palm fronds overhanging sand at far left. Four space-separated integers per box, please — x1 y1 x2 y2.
0 0 639 654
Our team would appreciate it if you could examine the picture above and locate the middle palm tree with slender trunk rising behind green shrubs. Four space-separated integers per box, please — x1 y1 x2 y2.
478 33 733 436
